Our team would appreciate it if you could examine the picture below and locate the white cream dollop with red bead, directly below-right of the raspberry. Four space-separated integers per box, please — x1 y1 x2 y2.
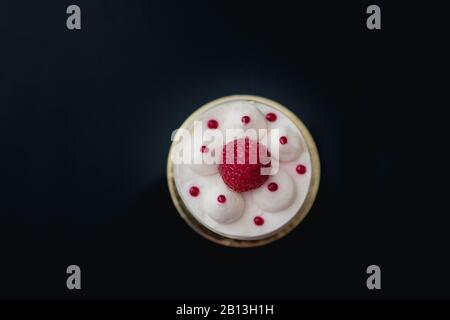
252 169 297 212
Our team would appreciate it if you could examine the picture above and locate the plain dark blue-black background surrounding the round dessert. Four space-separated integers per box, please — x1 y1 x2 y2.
0 0 444 299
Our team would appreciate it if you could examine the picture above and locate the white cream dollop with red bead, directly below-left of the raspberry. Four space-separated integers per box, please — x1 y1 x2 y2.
203 184 245 224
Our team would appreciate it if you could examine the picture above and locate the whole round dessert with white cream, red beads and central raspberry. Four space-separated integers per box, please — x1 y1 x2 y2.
167 96 320 247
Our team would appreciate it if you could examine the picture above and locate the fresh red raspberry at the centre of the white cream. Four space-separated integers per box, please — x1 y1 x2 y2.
219 138 270 192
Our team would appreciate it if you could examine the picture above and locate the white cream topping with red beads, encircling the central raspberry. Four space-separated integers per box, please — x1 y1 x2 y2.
174 98 311 240
